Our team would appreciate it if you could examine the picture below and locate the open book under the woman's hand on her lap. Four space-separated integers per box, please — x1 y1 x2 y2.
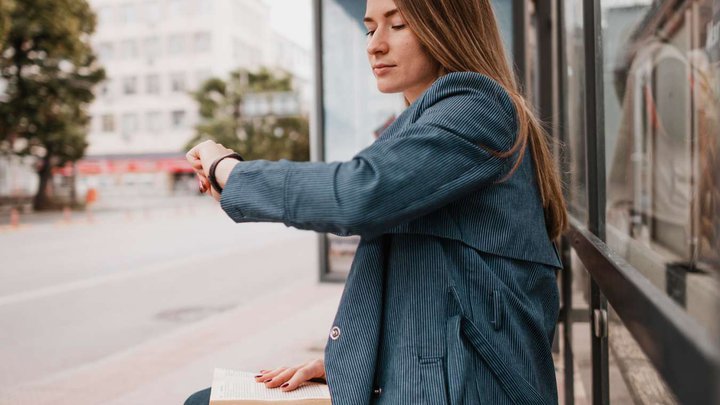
210 368 331 405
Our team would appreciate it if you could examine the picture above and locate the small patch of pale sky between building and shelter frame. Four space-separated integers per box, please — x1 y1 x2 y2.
264 0 312 49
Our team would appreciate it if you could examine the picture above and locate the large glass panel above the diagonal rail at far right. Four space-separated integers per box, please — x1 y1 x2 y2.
602 0 720 337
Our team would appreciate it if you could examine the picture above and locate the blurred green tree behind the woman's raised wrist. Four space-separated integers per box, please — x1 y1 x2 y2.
186 69 310 160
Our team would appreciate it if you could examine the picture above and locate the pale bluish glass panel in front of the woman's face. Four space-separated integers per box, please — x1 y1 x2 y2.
322 0 405 273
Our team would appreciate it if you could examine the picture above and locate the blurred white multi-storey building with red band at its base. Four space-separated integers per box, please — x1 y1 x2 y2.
74 0 311 196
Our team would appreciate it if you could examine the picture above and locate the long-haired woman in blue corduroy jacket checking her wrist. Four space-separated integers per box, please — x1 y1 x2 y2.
187 0 567 404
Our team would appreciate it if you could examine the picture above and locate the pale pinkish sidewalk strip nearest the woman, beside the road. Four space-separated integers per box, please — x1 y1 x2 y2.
3 273 342 405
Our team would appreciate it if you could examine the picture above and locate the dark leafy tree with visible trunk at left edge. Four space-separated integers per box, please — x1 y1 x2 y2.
0 0 105 210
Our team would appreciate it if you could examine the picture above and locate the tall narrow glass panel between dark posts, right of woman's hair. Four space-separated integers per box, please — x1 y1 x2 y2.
562 1 587 223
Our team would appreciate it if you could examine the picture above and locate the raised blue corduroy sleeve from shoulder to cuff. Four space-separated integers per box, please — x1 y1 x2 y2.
220 73 517 237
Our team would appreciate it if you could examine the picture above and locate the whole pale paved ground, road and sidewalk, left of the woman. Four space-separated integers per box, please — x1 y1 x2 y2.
0 198 342 404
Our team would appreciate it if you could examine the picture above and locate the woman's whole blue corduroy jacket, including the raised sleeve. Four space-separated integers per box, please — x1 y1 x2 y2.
220 72 561 405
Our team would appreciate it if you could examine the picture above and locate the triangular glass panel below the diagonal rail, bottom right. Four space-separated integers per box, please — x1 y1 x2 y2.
608 306 677 405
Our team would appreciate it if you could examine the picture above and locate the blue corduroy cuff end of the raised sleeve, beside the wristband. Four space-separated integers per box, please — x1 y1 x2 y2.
220 160 288 222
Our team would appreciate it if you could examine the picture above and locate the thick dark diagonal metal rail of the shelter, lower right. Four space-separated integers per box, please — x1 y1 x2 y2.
568 222 720 404
